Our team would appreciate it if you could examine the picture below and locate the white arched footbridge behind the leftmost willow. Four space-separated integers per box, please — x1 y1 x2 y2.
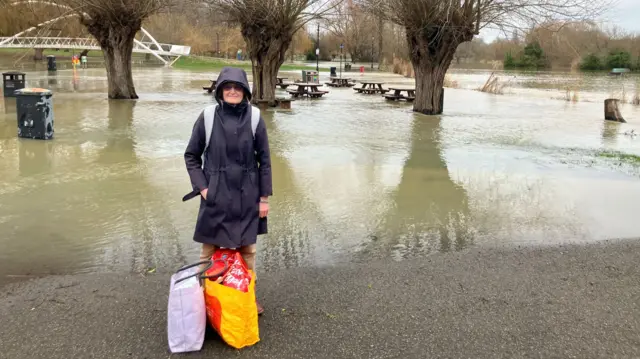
0 1 191 66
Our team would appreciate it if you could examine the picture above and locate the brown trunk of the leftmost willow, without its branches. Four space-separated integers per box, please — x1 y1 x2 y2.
85 18 141 99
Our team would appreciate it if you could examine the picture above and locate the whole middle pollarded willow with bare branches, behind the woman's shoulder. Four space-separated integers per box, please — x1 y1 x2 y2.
208 0 335 104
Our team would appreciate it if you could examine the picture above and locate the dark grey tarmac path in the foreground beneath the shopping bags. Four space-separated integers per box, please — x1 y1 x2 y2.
0 241 640 359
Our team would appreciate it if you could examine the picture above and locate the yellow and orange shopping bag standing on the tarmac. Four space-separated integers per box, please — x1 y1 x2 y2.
204 271 260 349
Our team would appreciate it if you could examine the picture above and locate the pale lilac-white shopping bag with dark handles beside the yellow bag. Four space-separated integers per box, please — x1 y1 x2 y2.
167 261 211 353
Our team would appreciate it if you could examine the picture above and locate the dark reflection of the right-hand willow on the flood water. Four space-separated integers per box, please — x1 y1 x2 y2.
362 114 473 258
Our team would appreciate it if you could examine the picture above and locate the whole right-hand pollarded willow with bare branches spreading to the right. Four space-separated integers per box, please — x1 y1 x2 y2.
360 0 614 115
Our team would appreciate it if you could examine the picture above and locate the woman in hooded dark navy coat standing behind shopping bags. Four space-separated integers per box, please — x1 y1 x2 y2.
183 67 272 314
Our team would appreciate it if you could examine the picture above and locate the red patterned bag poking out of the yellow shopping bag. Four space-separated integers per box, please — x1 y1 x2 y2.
206 249 251 293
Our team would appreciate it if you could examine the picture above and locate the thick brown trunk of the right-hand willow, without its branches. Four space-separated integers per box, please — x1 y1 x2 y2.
406 27 473 115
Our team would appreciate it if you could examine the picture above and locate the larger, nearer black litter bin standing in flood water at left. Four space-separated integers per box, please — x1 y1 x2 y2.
16 88 53 140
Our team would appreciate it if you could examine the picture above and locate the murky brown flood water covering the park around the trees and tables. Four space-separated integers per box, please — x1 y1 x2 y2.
0 68 640 282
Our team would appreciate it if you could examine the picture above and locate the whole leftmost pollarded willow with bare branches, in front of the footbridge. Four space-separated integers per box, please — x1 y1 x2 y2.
0 0 179 99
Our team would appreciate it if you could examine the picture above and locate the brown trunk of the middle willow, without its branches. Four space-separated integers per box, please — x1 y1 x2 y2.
243 29 293 106
